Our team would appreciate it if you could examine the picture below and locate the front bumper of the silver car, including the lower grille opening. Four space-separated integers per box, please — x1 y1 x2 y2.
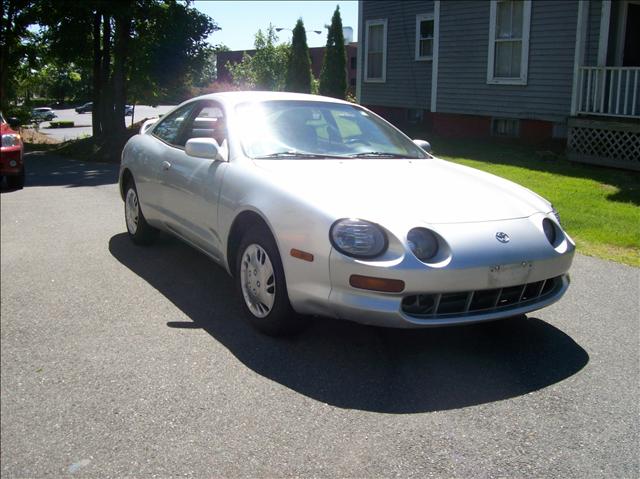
329 220 575 328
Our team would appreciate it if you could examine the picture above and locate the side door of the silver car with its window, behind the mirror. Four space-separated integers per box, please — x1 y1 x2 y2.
162 100 228 257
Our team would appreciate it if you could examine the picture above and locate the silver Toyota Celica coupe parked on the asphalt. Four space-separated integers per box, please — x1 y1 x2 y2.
120 92 575 334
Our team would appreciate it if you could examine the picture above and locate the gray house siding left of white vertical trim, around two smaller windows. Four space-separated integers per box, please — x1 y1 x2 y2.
359 1 433 110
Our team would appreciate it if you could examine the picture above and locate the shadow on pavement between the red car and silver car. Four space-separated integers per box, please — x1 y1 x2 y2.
0 151 119 193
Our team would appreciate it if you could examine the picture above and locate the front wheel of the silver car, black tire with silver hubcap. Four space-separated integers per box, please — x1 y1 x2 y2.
235 226 305 336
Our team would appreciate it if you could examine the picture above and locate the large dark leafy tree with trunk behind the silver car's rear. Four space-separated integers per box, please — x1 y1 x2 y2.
31 0 219 145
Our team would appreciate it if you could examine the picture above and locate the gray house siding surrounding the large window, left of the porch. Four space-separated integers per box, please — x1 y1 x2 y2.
437 0 578 121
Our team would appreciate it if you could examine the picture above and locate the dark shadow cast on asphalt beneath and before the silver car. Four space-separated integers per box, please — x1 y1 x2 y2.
109 233 589 414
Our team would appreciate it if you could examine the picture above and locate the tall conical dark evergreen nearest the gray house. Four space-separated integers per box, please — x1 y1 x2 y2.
320 6 347 100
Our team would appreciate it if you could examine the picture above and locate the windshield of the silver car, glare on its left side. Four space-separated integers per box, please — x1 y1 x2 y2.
236 100 429 159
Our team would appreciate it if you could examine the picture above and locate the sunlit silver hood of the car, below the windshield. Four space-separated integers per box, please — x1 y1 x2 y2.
255 159 551 224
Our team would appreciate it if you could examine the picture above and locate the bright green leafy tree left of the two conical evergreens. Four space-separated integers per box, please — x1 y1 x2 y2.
227 24 290 91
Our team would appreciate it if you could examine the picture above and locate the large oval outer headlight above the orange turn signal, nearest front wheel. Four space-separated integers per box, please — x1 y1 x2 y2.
329 218 388 258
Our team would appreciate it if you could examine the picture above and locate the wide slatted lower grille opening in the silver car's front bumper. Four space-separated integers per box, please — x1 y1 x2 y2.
402 276 562 319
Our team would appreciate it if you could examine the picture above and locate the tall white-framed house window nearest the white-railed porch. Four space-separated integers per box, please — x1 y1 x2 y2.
487 0 531 85
